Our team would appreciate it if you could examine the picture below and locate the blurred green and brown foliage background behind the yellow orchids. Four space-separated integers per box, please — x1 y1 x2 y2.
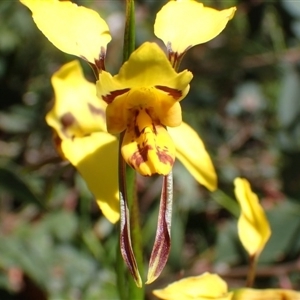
0 0 300 300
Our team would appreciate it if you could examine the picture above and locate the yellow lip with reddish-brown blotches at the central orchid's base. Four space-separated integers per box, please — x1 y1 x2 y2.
121 110 175 176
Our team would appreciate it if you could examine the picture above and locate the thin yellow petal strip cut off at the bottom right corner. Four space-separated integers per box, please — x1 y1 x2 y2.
232 288 300 300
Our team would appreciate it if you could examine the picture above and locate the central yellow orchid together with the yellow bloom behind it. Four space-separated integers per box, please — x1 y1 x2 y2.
20 0 235 286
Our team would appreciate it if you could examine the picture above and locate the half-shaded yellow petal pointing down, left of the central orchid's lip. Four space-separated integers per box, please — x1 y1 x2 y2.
61 132 120 223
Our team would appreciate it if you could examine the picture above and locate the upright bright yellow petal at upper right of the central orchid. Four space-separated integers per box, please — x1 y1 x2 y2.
154 0 236 54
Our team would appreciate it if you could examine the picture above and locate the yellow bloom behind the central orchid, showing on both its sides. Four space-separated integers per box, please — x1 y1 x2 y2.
46 61 216 223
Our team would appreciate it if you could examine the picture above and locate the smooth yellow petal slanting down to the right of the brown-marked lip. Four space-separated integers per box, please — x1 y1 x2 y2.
168 123 217 191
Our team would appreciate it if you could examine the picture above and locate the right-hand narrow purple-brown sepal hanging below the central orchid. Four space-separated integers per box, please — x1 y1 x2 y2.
146 172 173 284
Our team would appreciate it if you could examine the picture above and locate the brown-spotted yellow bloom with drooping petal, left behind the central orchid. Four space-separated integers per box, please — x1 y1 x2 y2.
46 61 119 223
